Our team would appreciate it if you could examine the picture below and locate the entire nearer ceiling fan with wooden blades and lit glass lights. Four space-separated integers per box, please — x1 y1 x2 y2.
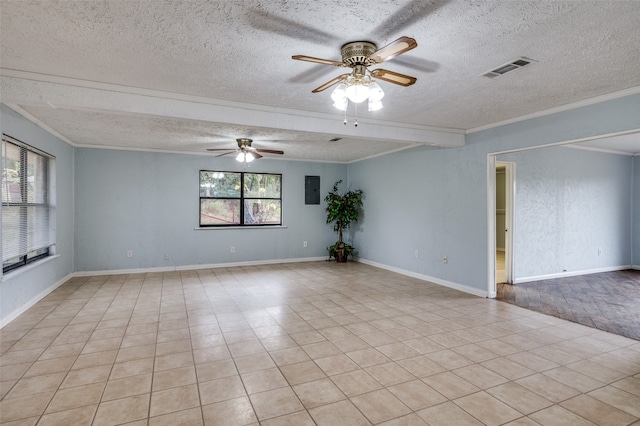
291 37 418 126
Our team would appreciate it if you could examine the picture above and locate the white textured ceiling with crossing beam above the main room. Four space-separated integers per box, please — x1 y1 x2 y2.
0 0 640 162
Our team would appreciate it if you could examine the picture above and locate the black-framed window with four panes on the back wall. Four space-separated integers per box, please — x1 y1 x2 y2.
200 170 282 227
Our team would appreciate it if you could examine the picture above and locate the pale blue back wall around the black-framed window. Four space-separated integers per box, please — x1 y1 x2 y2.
75 148 347 271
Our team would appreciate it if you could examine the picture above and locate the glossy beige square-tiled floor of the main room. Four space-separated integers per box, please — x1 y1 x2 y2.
0 262 640 426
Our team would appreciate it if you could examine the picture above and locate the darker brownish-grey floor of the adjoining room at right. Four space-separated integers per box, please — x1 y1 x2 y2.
497 270 640 340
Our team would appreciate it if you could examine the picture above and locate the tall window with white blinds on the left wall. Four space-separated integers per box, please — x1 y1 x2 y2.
2 135 53 272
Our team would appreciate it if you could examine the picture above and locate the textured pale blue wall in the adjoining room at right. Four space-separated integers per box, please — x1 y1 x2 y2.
498 147 633 282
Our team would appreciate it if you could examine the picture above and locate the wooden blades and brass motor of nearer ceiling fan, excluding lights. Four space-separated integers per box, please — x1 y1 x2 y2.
291 36 418 93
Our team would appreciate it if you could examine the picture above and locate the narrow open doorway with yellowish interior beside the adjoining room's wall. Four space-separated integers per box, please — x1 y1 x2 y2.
495 161 515 284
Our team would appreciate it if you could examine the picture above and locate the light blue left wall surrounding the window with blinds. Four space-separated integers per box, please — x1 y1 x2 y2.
0 104 74 326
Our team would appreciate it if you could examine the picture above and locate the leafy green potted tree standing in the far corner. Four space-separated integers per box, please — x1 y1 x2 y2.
324 180 364 262
